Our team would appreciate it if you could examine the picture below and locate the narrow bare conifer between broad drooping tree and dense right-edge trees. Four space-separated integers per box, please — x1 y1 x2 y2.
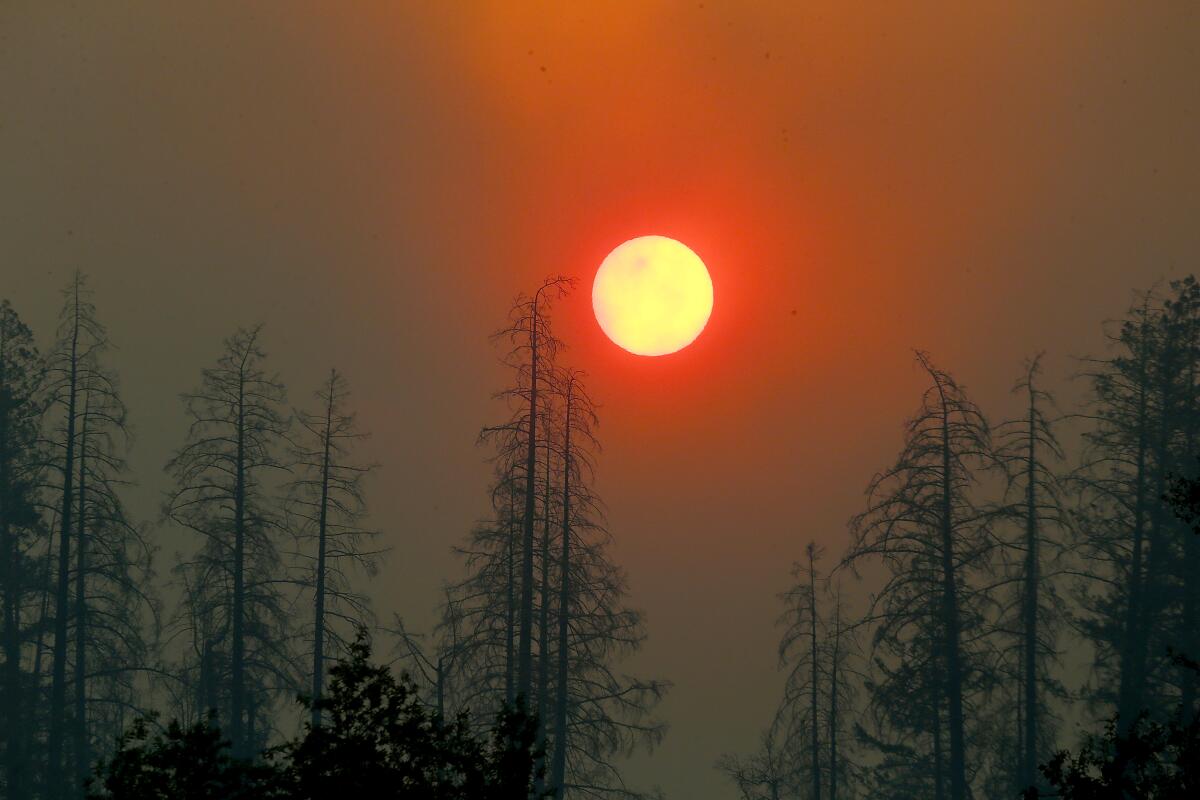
996 354 1069 792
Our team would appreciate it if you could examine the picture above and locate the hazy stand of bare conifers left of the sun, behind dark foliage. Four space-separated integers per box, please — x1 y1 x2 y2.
0 273 666 800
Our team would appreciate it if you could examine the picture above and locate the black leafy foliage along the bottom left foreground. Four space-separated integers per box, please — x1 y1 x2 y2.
88 636 540 800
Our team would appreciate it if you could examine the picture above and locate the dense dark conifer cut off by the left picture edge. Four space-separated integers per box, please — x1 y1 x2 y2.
0 300 47 800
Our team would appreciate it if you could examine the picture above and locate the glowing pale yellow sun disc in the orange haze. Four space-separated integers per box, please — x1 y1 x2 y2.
592 236 713 356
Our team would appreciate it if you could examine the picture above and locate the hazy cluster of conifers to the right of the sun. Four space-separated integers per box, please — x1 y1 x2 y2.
718 277 1200 800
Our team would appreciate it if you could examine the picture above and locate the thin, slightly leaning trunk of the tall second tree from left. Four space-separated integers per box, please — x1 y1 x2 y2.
46 281 80 800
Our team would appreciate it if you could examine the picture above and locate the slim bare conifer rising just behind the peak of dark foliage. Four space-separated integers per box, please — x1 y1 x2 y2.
288 369 380 726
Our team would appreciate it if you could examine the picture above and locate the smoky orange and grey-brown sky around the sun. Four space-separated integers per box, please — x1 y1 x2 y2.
0 0 1200 799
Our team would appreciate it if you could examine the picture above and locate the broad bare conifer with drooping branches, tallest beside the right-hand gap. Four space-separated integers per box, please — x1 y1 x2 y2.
845 353 996 800
